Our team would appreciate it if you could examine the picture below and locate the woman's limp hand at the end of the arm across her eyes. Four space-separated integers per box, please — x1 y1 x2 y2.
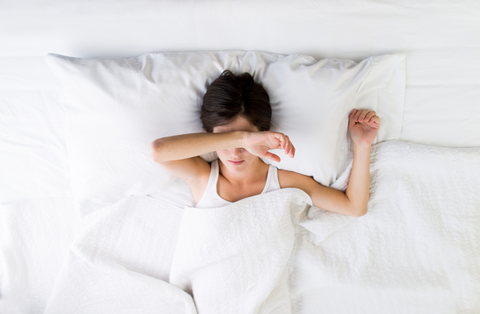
243 131 295 162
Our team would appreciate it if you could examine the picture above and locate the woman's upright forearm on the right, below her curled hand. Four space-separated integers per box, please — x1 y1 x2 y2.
345 144 371 215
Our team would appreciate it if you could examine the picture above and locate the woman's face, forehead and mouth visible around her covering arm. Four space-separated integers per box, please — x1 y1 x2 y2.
213 116 258 173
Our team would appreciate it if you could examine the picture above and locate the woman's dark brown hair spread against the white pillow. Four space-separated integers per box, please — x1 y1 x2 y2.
200 70 272 133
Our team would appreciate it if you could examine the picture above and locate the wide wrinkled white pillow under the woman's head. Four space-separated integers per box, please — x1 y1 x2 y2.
46 51 405 214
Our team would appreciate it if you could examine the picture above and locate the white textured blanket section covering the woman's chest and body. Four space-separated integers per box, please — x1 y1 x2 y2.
170 189 311 313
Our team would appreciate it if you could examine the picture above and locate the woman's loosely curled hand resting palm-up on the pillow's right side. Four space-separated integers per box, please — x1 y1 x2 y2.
348 109 380 146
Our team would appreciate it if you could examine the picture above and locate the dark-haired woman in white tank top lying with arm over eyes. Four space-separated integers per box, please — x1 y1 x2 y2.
151 70 380 217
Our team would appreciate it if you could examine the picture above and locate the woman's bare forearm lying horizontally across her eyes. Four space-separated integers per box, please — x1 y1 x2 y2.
151 131 244 162
